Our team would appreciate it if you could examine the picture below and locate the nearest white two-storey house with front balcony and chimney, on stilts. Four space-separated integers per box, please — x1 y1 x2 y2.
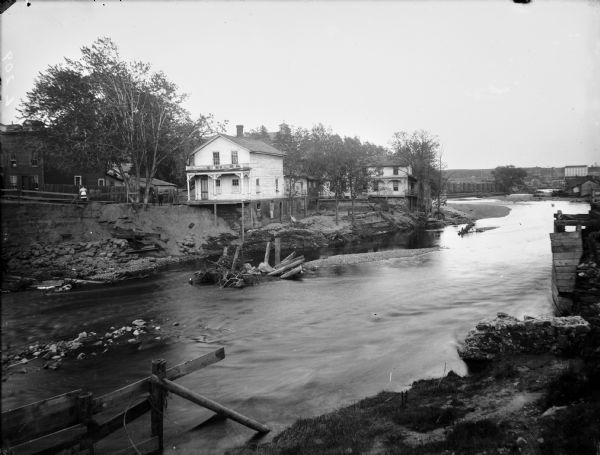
185 125 285 203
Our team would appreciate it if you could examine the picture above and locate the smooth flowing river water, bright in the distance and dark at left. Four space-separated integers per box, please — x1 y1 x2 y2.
2 201 589 453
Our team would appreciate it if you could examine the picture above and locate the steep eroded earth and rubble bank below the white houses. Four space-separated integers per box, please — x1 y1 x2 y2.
2 202 436 290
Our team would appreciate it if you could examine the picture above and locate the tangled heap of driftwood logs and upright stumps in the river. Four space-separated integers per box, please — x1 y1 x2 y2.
190 242 304 288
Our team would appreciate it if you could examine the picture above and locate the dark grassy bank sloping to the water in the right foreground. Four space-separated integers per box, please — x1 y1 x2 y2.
228 356 600 455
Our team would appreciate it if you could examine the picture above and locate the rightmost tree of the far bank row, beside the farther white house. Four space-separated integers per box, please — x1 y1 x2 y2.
392 130 440 213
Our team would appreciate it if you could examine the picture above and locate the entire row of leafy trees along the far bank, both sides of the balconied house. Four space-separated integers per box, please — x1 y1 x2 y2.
19 38 442 211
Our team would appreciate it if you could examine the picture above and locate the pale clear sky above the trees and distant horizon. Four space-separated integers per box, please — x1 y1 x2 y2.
0 0 600 169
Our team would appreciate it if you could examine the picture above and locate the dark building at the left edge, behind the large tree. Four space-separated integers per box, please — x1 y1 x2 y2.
0 120 46 190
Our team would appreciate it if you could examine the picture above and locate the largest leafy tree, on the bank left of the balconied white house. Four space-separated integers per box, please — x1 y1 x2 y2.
20 38 218 203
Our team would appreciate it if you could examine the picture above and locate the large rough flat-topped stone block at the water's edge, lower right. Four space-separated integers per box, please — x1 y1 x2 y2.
458 313 590 361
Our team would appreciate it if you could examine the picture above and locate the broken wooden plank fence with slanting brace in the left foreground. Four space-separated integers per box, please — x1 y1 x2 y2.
2 348 270 455
